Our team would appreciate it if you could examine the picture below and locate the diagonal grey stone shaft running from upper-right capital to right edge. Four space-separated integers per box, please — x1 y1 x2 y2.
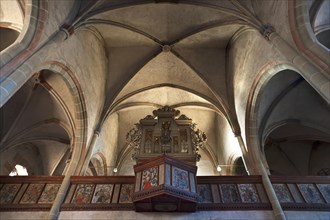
262 26 330 104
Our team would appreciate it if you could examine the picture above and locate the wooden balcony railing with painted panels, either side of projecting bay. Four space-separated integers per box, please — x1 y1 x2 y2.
0 176 330 211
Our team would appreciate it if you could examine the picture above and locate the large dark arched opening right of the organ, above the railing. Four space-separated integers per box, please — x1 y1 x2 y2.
257 70 330 175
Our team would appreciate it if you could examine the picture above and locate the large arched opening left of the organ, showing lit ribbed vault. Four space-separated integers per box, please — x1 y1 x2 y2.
0 72 72 175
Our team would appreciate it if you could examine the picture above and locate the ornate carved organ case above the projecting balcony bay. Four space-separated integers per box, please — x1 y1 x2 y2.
126 106 206 164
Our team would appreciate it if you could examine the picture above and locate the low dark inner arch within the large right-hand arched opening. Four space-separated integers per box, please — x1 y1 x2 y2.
264 122 330 176
